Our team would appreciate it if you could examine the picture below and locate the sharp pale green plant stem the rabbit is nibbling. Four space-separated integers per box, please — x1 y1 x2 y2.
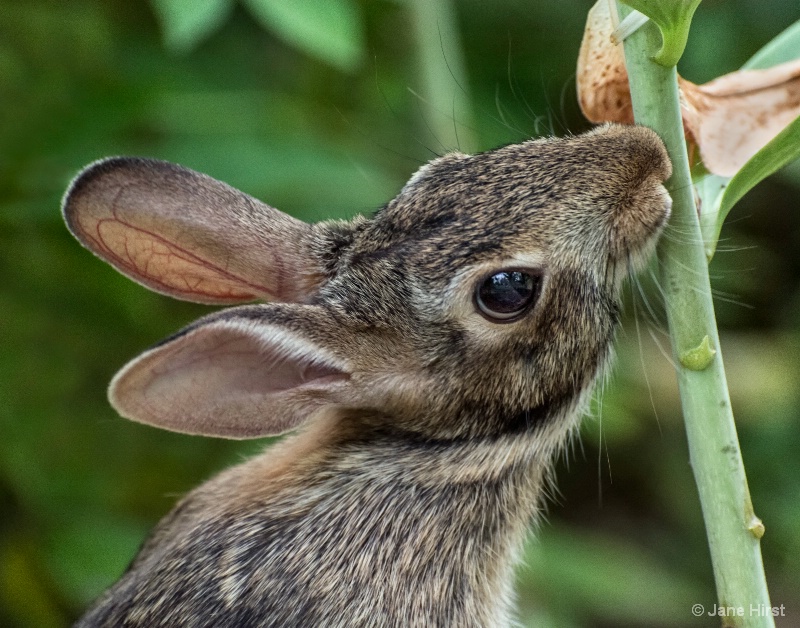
618 3 774 627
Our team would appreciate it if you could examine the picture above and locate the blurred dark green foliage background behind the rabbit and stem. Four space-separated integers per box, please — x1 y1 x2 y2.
0 0 800 627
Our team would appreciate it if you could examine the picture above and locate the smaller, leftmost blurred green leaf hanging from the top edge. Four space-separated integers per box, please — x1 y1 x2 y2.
151 0 233 52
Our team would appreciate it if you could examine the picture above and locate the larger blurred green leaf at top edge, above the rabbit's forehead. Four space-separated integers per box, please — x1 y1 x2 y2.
245 0 365 72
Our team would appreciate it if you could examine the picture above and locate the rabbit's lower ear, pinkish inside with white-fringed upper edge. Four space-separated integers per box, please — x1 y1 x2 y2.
109 305 350 438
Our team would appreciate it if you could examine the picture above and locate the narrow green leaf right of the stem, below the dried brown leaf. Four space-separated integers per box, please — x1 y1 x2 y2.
698 117 800 260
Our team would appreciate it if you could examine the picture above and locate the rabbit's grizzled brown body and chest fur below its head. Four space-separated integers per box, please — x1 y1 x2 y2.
76 417 570 627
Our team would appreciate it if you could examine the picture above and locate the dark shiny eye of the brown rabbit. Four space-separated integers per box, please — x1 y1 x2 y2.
475 269 539 323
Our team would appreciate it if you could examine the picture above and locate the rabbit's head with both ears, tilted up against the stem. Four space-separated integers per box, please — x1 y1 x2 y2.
64 126 671 439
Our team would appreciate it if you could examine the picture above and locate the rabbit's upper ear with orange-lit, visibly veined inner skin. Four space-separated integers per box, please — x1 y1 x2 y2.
63 157 321 304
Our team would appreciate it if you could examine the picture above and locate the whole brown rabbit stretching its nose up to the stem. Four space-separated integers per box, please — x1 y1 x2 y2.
63 125 671 628
